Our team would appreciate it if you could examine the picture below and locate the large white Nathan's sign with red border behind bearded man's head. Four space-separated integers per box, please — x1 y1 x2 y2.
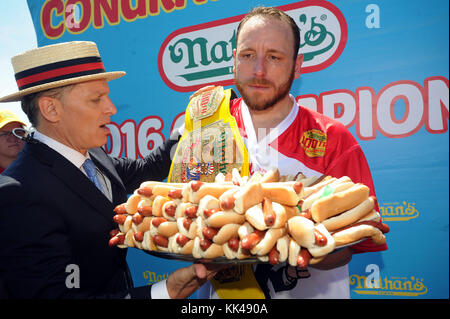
158 0 347 92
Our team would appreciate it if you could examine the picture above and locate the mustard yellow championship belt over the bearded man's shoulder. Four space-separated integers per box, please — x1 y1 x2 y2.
168 86 264 299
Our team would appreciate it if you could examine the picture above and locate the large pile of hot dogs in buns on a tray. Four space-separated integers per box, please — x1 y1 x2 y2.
109 170 389 267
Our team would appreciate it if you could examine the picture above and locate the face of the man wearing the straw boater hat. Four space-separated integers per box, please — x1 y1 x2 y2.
58 80 117 154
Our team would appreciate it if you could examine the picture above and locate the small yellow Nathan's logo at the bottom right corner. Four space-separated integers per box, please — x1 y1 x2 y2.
349 264 428 297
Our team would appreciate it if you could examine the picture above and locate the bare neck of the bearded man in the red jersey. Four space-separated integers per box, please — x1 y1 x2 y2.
248 96 294 141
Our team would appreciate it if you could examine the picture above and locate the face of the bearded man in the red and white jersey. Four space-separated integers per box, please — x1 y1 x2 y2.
234 17 296 110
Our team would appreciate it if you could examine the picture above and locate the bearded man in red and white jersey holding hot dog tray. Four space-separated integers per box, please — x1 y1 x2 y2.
201 7 387 299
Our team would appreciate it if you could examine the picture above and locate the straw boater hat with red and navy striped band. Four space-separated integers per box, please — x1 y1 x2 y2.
0 41 125 102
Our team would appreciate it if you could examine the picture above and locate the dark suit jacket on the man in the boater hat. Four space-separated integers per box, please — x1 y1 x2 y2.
0 137 178 298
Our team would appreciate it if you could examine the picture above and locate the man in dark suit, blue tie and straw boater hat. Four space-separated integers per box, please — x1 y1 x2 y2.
0 41 220 298
